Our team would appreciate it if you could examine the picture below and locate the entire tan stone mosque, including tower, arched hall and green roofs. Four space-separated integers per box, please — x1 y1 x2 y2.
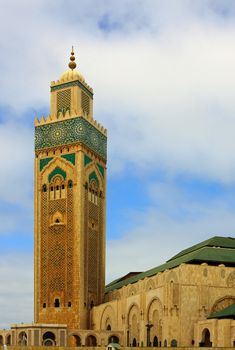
0 50 235 347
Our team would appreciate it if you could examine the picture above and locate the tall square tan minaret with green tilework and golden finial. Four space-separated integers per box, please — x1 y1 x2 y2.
34 49 107 329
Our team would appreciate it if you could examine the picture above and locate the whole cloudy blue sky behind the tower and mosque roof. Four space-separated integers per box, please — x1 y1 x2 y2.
0 0 235 328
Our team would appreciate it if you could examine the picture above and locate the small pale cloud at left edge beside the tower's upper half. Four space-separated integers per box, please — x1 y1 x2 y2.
0 122 33 208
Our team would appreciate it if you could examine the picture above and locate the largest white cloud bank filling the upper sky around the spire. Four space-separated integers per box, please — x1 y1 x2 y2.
0 0 235 183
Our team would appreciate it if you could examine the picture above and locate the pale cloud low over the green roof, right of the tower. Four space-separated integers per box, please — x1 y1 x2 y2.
107 183 235 282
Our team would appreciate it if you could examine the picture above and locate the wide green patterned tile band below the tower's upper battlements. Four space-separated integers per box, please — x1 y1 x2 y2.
35 117 107 160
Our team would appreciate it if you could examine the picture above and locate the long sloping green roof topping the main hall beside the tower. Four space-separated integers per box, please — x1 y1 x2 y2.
105 237 235 293
